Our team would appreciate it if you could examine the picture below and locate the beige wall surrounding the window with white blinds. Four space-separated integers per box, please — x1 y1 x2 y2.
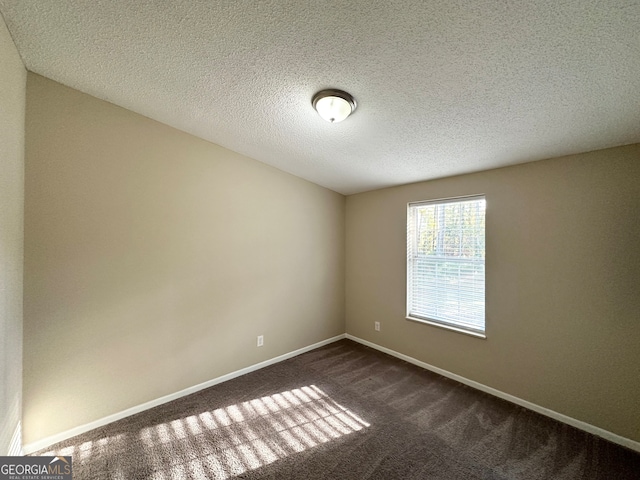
346 145 640 441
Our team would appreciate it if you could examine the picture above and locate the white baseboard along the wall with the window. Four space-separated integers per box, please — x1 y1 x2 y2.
345 333 640 452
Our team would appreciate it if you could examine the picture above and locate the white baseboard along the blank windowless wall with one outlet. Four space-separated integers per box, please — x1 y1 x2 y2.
22 333 346 455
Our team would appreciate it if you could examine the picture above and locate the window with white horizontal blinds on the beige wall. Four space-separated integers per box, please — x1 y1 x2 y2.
407 196 486 337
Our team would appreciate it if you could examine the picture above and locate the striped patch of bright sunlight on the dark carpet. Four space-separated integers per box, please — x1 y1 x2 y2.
47 385 370 480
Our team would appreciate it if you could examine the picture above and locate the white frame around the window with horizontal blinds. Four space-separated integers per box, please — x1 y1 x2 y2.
405 194 487 339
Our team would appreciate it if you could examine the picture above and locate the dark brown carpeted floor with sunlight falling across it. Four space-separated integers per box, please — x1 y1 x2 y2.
33 340 640 480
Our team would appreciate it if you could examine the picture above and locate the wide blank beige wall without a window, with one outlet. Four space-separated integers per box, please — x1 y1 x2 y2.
24 73 345 443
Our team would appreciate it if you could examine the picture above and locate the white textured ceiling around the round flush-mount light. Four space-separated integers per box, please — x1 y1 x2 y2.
0 0 640 194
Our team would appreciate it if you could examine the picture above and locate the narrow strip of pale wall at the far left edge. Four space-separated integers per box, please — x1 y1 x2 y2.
0 16 27 455
